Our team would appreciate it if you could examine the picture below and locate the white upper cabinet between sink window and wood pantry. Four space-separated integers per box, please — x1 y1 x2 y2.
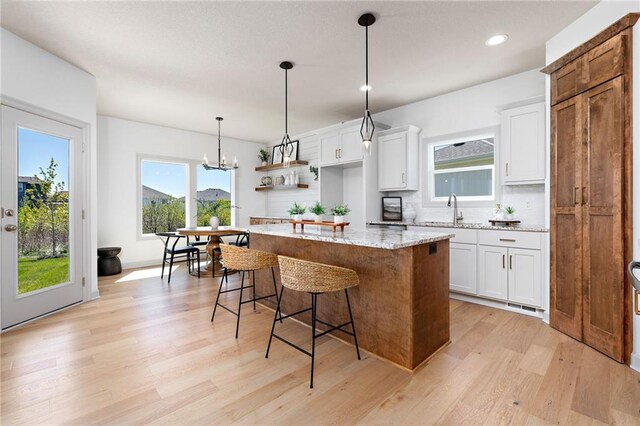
501 102 546 185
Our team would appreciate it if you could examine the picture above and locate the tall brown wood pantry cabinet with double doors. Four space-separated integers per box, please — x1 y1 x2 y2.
543 15 637 362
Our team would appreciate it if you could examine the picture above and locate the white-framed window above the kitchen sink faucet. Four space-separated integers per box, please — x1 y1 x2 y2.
427 132 495 201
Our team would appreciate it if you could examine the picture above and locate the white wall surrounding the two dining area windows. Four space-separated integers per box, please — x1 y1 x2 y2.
98 116 265 267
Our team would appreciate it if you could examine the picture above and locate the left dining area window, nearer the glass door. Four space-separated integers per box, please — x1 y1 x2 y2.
140 160 188 235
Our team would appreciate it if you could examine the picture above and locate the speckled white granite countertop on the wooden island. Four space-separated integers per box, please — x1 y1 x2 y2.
247 224 454 250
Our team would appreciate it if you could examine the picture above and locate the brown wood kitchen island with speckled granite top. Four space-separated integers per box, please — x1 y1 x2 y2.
249 224 453 370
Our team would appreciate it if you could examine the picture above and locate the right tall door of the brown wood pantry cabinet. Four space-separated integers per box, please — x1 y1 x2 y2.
580 77 630 362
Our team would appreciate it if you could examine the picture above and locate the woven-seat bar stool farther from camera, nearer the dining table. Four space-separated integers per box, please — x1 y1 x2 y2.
211 244 278 339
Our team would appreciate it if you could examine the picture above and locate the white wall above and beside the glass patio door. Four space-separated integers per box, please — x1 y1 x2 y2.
0 29 98 299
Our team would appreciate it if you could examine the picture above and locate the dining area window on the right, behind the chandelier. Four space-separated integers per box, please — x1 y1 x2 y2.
195 167 233 226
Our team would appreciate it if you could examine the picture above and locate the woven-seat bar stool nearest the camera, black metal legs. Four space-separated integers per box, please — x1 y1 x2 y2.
265 256 360 389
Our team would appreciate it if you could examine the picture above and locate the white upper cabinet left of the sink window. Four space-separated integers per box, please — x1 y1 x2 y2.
374 126 420 191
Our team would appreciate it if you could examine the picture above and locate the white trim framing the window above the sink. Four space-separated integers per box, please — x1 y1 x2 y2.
422 126 502 207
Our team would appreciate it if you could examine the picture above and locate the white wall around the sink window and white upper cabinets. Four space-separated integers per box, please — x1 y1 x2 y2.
373 70 545 225
